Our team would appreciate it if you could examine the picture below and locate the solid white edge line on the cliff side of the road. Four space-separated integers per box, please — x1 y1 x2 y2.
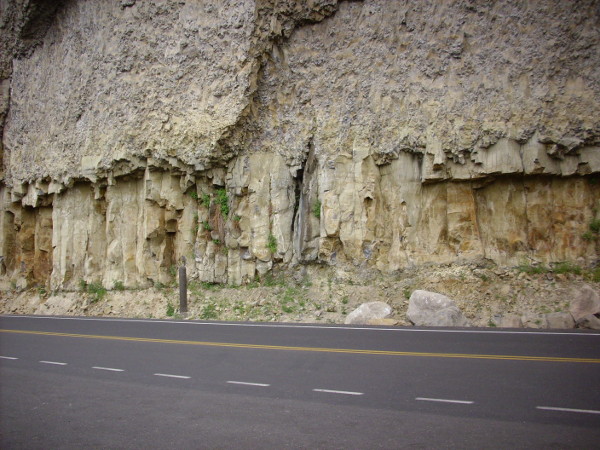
0 314 600 336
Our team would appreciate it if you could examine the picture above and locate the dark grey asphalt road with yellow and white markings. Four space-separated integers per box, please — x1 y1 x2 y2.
0 316 600 449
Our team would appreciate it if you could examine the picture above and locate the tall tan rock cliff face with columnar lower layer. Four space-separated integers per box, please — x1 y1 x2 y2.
0 0 600 289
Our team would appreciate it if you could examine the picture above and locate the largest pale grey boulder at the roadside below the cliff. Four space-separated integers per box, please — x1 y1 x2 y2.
406 290 470 327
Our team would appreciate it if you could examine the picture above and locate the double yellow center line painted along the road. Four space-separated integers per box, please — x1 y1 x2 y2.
0 329 600 364
